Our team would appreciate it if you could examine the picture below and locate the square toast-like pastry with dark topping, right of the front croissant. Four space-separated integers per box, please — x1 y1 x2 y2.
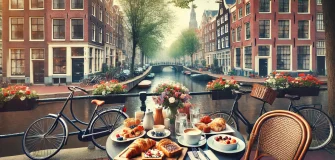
156 139 183 158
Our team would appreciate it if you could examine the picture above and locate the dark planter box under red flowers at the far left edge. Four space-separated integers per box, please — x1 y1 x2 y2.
0 98 37 112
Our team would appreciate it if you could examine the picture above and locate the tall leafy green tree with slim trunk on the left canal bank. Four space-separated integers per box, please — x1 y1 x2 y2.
119 0 172 75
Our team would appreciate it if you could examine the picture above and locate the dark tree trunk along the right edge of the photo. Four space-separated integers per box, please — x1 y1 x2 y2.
322 0 335 121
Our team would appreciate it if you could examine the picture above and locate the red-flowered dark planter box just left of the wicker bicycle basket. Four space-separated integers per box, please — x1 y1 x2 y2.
206 77 240 100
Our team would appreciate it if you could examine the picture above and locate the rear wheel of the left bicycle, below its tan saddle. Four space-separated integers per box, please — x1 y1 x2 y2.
89 109 128 150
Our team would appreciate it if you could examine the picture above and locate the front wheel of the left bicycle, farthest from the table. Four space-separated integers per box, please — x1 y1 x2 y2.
22 117 68 159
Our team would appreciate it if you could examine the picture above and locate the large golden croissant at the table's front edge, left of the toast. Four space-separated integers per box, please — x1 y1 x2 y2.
124 138 156 158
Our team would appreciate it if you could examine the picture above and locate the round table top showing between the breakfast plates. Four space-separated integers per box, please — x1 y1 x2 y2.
106 128 247 160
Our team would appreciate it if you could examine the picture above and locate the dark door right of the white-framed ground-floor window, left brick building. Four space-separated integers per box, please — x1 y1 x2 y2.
72 58 84 82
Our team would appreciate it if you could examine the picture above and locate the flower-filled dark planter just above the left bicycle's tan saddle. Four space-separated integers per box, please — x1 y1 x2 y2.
93 80 127 104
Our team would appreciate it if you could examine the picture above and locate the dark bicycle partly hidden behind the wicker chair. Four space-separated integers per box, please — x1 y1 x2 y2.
210 90 333 150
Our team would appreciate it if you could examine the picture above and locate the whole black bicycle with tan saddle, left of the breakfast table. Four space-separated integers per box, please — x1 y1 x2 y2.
22 87 129 159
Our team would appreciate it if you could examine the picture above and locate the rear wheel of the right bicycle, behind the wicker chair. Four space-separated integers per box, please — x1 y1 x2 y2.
297 107 334 150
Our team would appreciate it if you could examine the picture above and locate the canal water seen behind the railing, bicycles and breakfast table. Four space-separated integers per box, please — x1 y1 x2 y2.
0 67 327 157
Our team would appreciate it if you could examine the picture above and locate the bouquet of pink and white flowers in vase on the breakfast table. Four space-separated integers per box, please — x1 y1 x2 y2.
153 82 192 123
